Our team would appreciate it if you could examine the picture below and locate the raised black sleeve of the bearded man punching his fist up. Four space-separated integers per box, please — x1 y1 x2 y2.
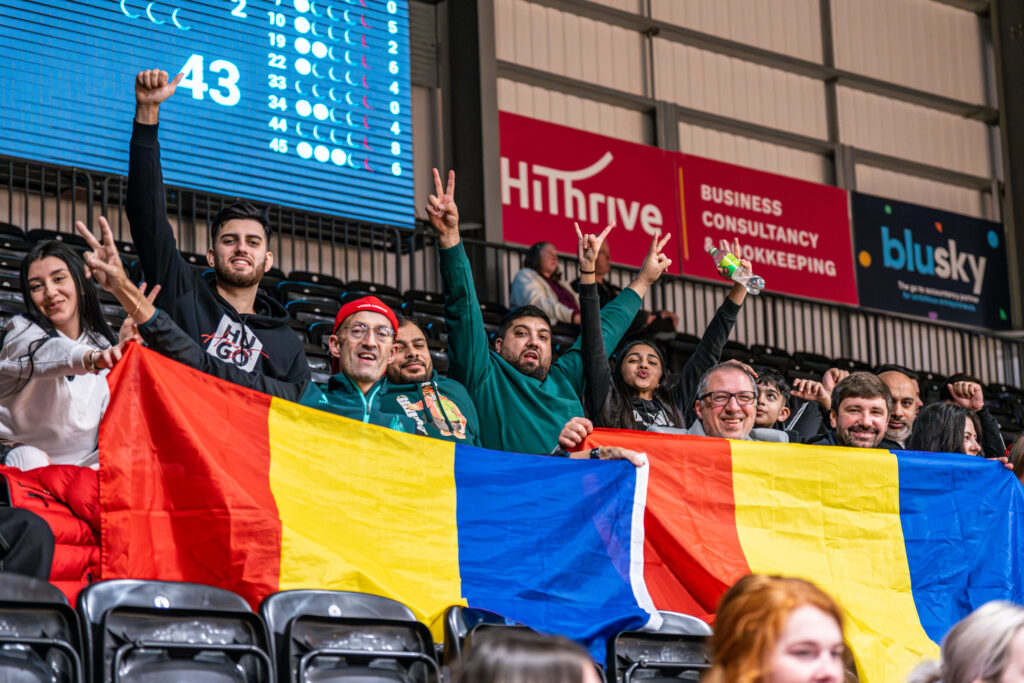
125 122 196 296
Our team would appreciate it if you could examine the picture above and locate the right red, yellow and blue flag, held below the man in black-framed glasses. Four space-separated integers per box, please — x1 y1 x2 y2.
588 430 1024 683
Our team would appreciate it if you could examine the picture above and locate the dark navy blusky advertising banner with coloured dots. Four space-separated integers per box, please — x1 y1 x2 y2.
851 193 1010 329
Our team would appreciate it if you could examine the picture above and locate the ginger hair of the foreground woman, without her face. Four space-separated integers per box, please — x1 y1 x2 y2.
701 574 843 683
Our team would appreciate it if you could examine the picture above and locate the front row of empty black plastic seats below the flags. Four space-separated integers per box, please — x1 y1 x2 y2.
0 573 711 683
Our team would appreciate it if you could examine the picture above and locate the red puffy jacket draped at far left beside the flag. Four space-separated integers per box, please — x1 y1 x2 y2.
0 465 99 605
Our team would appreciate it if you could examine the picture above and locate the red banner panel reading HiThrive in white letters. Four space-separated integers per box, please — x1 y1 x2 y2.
499 112 684 273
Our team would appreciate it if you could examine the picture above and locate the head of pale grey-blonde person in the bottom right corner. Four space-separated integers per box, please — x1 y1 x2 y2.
907 600 1024 683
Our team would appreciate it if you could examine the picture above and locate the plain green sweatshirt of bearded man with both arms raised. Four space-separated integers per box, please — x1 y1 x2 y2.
438 243 641 455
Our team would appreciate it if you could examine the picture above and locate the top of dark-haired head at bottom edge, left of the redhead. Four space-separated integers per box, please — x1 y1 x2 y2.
452 629 601 683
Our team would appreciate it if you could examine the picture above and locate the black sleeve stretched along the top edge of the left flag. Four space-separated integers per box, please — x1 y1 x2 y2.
138 310 308 401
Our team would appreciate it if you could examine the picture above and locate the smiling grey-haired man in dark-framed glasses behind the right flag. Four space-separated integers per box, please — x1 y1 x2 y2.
687 360 790 441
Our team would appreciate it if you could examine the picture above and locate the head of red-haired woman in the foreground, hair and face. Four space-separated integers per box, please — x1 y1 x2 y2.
700 574 846 683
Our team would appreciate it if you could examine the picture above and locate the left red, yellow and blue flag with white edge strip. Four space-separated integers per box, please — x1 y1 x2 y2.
99 347 659 658
